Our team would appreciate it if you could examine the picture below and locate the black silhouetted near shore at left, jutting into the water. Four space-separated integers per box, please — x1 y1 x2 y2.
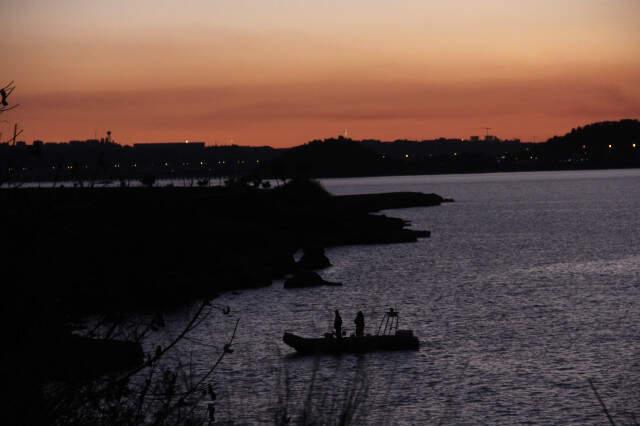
0 179 452 420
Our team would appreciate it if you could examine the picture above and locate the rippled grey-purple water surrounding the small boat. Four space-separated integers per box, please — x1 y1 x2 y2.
161 170 640 425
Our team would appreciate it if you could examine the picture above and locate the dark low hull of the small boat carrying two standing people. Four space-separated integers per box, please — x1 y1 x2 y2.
282 333 420 354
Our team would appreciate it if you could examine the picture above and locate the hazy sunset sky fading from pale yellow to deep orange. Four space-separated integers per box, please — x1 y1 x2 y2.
0 0 640 146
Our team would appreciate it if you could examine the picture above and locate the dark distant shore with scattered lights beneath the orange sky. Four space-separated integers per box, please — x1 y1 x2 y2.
0 120 640 186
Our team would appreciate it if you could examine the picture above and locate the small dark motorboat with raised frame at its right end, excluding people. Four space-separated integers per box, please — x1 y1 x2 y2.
282 309 420 355
